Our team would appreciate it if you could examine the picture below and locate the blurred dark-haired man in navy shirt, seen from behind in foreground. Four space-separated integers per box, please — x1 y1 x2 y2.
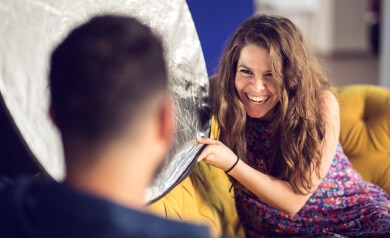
0 16 209 237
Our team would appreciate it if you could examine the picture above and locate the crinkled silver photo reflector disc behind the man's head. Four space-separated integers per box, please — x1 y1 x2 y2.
0 0 210 202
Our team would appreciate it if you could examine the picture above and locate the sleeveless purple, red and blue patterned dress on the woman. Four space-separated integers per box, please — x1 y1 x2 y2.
233 118 390 237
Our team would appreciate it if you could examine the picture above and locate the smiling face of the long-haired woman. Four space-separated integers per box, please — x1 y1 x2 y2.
235 44 279 119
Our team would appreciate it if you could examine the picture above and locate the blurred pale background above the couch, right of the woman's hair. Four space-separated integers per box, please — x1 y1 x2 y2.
255 0 390 88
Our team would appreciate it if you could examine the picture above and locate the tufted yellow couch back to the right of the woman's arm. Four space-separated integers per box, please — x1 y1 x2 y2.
337 85 390 193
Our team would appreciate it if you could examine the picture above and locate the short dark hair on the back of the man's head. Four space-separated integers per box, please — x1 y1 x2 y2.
50 15 168 145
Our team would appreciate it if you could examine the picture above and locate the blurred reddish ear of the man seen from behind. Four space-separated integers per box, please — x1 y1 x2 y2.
160 97 175 146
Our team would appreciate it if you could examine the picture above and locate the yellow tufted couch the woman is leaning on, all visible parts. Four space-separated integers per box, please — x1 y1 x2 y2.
149 85 390 237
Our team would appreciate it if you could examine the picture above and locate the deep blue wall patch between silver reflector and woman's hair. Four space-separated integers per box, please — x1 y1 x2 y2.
187 0 254 76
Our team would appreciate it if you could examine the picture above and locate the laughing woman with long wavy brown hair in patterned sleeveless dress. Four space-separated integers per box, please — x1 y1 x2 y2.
198 15 390 237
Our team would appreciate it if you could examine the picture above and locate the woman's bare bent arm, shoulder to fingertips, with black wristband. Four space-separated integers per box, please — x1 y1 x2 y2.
198 91 340 215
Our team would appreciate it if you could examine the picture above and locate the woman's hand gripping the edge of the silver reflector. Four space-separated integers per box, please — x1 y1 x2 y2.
196 138 237 171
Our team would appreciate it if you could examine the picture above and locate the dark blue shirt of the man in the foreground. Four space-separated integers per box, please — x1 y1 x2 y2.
0 179 210 238
